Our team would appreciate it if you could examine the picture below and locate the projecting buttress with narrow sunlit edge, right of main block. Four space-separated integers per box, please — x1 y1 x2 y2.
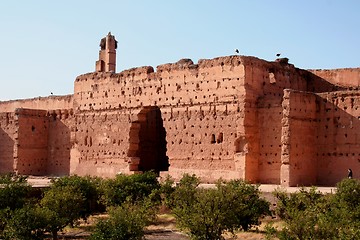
280 90 318 186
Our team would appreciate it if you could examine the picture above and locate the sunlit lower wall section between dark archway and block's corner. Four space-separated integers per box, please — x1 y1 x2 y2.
162 104 242 182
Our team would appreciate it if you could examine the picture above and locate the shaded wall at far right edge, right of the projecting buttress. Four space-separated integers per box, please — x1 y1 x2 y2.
316 90 360 185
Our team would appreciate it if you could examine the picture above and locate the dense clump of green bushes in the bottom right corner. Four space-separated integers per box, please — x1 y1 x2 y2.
268 179 360 239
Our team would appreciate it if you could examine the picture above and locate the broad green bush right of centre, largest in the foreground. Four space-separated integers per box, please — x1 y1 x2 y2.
172 175 270 240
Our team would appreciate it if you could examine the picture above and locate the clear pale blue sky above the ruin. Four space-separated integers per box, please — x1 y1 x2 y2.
0 0 360 101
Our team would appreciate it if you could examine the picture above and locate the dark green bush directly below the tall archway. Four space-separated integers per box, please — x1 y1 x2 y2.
102 172 160 206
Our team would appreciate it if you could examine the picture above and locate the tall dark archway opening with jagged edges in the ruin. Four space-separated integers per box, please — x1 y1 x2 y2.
127 106 169 174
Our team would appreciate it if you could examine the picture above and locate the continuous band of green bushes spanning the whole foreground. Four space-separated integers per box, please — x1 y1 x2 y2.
0 172 360 240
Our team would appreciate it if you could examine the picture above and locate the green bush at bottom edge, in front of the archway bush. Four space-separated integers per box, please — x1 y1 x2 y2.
90 203 152 240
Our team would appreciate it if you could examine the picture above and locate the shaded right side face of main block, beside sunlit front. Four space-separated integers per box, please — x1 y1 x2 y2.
242 57 337 184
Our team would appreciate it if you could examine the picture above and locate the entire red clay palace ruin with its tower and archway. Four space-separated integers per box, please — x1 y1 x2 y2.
0 34 360 186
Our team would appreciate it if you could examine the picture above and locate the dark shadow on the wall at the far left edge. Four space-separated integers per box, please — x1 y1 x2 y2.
0 128 14 173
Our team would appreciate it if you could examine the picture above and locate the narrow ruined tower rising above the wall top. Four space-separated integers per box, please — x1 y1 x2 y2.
95 32 117 72
